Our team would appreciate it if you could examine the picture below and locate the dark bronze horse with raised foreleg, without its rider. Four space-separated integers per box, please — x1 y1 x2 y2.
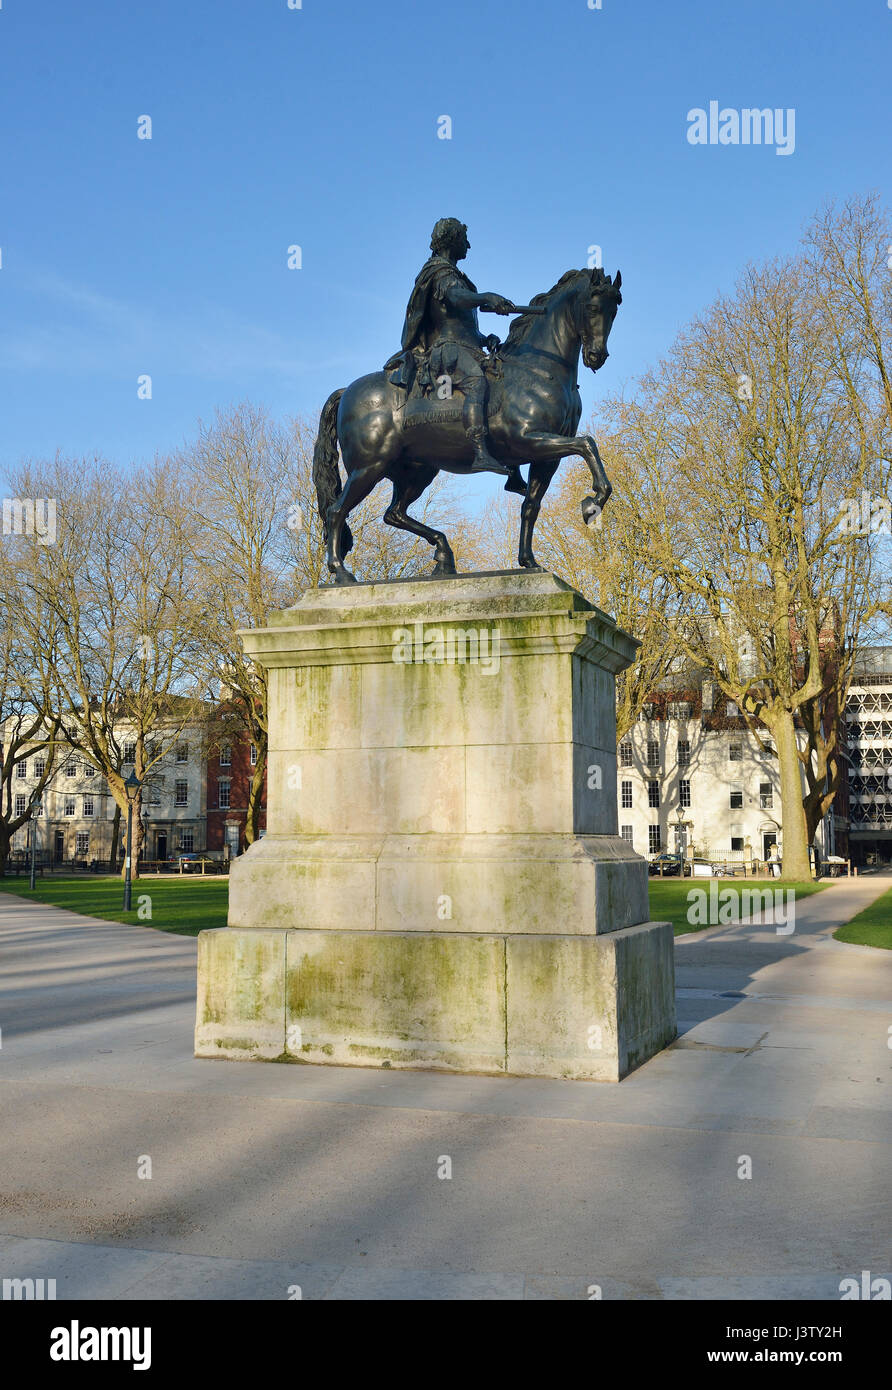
313 270 622 584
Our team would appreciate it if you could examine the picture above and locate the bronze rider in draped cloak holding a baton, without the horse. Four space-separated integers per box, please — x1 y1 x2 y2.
385 217 515 475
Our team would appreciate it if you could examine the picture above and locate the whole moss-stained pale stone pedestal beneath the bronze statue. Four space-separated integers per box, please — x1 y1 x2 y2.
196 571 675 1080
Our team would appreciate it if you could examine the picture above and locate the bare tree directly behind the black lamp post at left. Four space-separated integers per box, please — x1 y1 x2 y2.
15 459 206 878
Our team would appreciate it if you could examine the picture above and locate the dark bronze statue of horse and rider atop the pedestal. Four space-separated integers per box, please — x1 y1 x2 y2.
313 217 622 584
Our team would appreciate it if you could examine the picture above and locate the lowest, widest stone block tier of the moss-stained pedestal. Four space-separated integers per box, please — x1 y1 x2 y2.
196 922 666 1081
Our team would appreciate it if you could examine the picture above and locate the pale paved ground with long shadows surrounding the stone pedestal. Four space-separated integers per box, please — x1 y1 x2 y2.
0 874 892 1300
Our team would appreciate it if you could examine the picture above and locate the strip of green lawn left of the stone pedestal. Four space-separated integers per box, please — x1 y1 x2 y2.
0 874 229 937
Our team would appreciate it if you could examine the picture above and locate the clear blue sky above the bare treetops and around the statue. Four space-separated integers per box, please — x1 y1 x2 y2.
0 0 892 492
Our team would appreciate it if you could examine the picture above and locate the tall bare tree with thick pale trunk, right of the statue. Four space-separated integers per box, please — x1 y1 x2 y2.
613 233 875 877
